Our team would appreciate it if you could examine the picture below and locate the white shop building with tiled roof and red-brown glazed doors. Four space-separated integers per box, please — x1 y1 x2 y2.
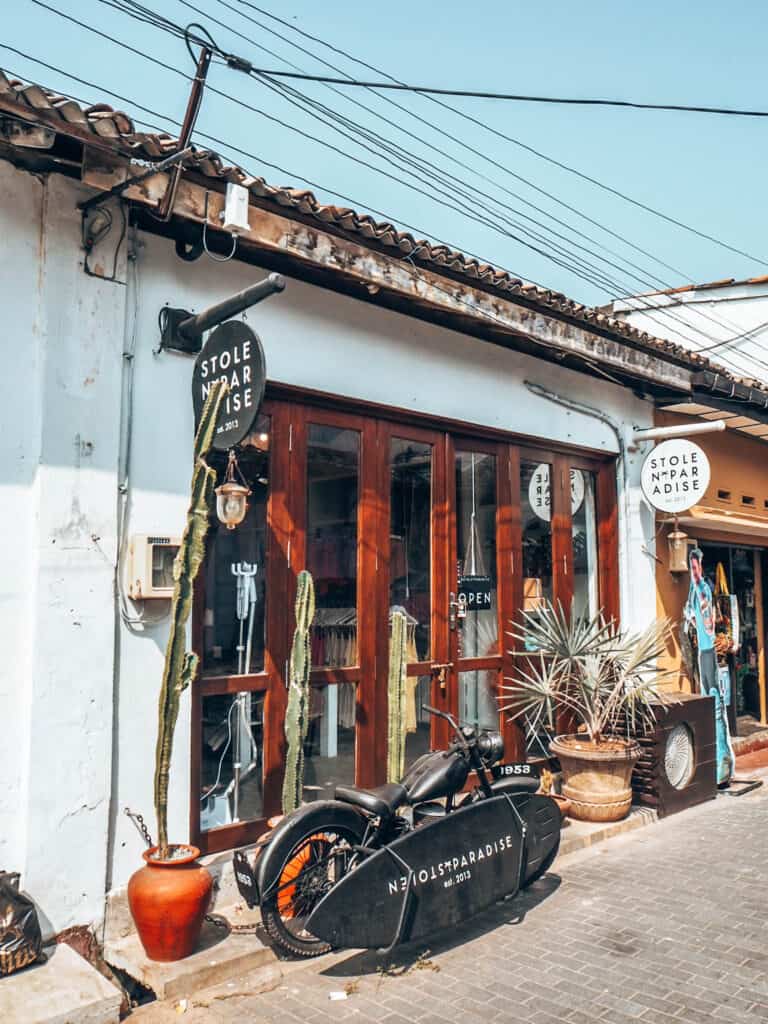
0 74 768 932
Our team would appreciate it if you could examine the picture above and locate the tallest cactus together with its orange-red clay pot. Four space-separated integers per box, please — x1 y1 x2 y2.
128 382 226 962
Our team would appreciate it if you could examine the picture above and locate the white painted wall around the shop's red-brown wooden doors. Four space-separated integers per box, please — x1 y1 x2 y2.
0 165 655 929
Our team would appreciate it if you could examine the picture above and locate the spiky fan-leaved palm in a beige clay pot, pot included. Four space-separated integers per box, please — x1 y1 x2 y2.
502 602 670 821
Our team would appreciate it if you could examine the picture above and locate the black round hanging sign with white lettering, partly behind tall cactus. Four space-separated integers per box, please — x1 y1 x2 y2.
193 321 266 452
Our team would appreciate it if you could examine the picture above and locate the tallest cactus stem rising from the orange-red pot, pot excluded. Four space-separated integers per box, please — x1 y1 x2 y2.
155 381 226 858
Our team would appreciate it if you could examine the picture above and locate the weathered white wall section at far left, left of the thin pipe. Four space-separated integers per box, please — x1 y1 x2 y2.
0 164 125 931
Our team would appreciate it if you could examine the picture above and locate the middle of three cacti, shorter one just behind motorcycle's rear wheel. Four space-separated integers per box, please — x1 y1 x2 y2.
283 571 314 814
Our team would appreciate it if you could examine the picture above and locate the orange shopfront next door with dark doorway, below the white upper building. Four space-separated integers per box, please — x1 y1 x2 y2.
656 413 768 735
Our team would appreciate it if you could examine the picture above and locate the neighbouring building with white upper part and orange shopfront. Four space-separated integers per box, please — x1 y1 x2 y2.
611 276 768 736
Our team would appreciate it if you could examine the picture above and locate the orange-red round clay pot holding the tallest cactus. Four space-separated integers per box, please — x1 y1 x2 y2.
128 846 213 963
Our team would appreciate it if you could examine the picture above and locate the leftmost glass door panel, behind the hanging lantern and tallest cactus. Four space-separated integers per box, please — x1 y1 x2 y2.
189 403 283 853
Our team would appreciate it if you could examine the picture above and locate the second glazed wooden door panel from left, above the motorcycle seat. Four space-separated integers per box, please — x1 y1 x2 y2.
286 407 375 790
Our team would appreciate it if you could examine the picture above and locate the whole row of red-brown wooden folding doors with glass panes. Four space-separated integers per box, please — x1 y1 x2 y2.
190 399 615 852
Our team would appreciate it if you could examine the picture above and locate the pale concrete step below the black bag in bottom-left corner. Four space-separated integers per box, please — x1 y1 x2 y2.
0 943 122 1024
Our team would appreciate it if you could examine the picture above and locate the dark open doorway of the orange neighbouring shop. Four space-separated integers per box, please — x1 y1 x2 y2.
699 541 766 734
